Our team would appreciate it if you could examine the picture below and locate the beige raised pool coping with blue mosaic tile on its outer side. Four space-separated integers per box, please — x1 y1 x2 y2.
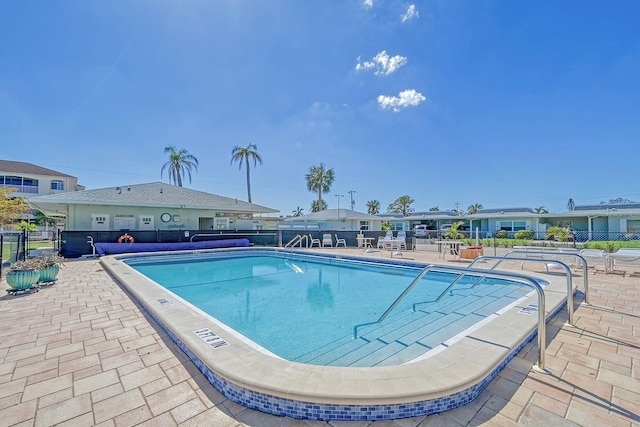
100 248 566 420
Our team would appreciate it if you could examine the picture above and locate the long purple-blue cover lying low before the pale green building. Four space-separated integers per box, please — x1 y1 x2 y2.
94 239 249 255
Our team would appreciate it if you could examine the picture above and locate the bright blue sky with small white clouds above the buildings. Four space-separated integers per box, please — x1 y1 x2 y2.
0 0 640 215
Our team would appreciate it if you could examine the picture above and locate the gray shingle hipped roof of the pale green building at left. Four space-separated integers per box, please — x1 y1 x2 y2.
29 182 278 213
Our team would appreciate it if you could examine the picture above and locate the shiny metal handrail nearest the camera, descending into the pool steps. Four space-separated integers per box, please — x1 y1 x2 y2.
353 264 547 371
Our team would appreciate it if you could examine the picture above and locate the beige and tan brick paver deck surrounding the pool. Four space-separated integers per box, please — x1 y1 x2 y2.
0 249 640 427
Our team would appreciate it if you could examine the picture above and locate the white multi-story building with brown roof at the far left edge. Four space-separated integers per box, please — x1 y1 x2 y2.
0 160 84 198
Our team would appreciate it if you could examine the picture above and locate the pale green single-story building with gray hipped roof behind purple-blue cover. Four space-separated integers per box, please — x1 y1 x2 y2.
28 182 278 231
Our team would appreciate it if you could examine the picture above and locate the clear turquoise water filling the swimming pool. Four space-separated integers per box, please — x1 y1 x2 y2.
126 252 530 366
